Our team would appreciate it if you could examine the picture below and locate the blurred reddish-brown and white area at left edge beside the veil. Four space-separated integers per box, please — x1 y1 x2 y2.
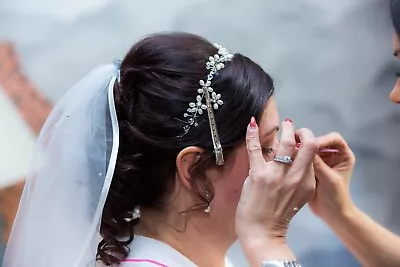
0 42 52 261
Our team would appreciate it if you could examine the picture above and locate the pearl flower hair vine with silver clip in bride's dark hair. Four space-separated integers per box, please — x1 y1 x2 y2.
183 44 233 165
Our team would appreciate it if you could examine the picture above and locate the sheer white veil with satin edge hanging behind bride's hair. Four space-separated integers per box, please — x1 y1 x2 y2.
3 64 119 267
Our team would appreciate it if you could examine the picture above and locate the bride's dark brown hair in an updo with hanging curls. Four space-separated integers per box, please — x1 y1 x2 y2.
97 33 274 265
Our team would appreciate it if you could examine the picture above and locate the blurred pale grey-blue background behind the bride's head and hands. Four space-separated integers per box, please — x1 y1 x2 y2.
0 0 400 267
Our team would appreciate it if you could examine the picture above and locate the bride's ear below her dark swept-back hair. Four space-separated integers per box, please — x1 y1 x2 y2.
176 146 204 189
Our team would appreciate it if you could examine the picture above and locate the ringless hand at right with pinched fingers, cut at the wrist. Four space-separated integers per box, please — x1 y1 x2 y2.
309 133 355 223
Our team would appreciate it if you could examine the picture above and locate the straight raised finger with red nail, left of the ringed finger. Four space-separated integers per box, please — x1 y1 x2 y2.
246 117 265 170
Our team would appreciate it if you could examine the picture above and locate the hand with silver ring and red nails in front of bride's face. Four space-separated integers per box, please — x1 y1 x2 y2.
236 119 318 266
